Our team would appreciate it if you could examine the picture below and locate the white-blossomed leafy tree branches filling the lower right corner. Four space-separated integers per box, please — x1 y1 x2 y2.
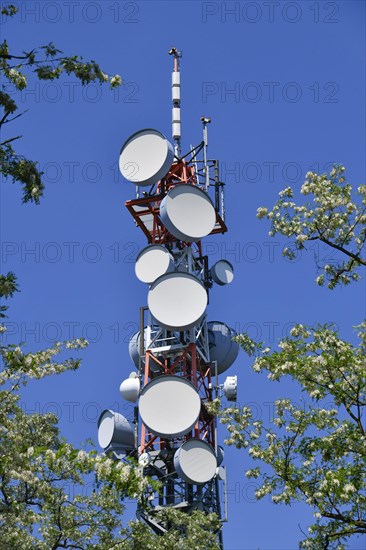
221 323 366 550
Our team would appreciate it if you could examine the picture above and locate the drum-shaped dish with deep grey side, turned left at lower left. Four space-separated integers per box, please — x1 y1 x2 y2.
98 409 135 449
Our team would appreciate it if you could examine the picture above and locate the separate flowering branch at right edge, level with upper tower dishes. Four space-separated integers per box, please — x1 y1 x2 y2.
257 165 366 289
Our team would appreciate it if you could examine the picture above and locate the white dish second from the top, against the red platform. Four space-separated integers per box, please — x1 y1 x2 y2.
160 183 216 242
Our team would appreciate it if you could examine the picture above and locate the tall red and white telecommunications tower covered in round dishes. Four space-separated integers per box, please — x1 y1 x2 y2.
98 48 239 547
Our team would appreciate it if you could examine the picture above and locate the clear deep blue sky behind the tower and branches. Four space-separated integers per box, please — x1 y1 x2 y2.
1 0 365 550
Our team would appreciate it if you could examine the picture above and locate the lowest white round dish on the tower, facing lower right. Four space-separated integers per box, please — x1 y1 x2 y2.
174 439 217 485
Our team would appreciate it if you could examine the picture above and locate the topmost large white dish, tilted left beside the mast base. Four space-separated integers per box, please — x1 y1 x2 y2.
119 128 174 186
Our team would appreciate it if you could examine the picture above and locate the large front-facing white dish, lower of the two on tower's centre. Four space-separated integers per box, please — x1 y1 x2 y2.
139 375 201 439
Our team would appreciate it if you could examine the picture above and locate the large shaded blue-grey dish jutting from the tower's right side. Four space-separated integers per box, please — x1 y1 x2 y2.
207 321 240 374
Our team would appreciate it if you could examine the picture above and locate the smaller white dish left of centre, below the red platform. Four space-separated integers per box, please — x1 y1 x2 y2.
135 248 174 284
